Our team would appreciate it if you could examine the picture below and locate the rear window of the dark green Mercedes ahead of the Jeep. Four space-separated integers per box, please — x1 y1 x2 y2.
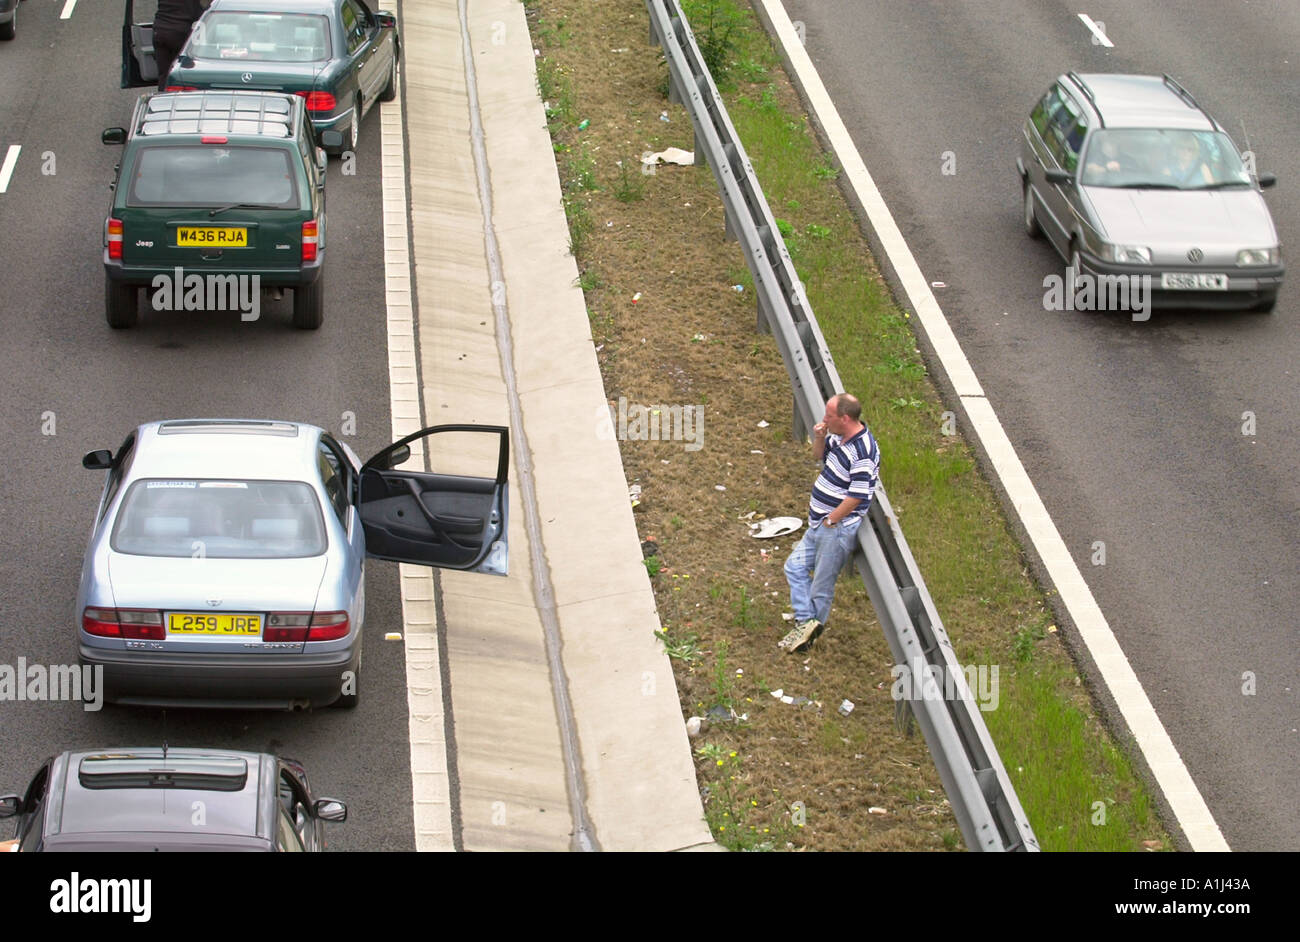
186 10 329 62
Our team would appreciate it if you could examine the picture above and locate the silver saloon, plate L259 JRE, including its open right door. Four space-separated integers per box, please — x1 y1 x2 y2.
77 420 510 709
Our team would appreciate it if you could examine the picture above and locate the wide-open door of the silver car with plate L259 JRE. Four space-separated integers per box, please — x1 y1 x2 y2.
355 425 510 576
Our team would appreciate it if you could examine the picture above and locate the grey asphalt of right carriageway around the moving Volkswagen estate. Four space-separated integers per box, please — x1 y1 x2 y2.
784 0 1300 851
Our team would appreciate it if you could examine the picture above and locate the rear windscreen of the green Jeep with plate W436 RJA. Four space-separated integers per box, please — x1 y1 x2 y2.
126 144 300 209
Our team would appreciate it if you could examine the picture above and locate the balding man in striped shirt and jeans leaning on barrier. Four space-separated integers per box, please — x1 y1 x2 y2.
777 392 880 654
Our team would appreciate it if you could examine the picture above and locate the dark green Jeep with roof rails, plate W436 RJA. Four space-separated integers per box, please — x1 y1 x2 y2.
103 91 325 330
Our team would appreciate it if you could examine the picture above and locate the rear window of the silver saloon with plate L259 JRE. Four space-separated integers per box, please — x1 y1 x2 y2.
111 478 326 559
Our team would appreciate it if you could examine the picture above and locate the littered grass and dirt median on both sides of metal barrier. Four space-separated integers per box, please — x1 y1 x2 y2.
524 0 1170 850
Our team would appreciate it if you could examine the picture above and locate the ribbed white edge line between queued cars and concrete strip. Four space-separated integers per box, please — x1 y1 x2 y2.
378 73 455 851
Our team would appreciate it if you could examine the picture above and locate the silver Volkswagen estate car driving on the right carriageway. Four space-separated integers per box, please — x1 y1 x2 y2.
1017 71 1284 311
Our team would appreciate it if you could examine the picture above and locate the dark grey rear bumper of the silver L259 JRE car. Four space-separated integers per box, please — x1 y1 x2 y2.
78 642 360 709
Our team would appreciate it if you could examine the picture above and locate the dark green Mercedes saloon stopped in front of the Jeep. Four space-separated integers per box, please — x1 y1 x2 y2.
124 0 399 152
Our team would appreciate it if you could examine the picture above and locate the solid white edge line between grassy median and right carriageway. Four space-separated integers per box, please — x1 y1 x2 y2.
761 0 1230 851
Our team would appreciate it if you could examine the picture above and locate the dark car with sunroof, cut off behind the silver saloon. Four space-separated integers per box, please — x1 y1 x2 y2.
0 746 347 852
